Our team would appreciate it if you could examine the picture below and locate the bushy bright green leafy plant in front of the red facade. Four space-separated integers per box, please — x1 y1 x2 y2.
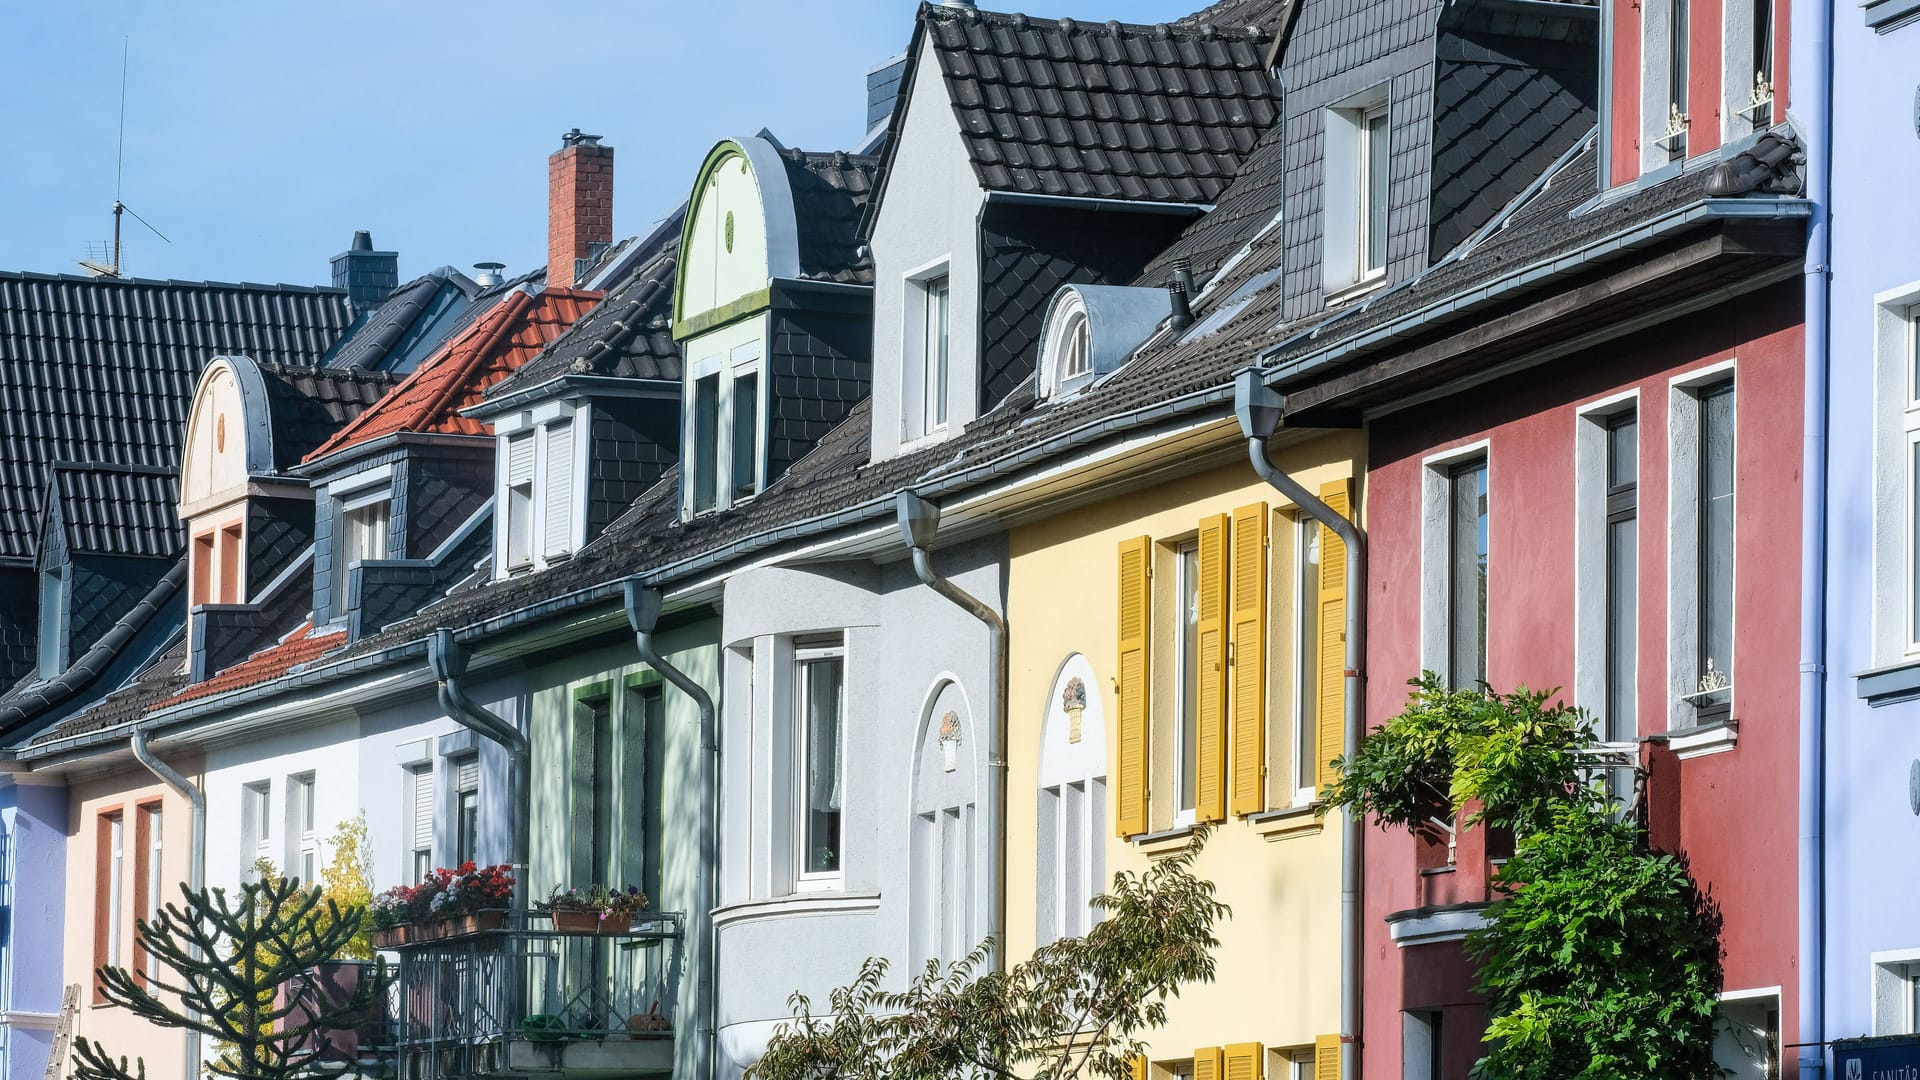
1325 673 1722 1080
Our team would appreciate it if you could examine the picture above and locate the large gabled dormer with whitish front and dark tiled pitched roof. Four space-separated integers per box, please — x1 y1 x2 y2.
866 6 1279 459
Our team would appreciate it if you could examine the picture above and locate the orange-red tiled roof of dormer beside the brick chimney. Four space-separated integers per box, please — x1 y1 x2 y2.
305 288 601 461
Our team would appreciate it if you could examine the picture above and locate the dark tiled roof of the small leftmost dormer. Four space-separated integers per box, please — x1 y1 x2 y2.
52 461 186 559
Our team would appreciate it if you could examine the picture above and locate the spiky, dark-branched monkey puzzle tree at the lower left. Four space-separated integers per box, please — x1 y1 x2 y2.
73 876 386 1080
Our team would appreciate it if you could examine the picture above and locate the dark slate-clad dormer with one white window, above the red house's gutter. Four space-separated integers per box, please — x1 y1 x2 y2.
1267 0 1599 321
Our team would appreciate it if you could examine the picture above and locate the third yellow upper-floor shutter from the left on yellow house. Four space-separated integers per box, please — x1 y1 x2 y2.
1233 502 1267 815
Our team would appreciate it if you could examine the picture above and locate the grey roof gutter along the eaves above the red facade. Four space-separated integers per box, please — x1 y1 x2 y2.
1256 196 1812 384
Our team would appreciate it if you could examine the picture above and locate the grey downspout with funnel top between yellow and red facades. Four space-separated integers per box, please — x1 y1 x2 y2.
1233 371 1367 1080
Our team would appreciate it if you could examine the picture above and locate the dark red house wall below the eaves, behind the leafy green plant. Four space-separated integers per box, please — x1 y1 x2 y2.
1361 281 1803 1080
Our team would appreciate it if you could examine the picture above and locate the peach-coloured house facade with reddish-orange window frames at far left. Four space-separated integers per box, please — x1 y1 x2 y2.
63 759 202 1080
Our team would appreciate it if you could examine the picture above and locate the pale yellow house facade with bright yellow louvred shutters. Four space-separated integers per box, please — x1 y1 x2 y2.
1006 429 1363 1080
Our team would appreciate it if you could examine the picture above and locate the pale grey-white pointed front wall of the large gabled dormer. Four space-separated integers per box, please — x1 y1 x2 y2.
870 40 991 461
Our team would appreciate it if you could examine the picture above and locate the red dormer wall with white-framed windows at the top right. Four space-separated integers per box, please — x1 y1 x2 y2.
1601 0 1788 184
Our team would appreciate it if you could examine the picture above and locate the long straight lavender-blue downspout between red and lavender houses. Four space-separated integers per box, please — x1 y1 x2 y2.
1793 0 1834 1080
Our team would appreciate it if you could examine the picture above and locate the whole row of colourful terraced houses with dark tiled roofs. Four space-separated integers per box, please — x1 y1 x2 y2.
0 0 1920 1080
